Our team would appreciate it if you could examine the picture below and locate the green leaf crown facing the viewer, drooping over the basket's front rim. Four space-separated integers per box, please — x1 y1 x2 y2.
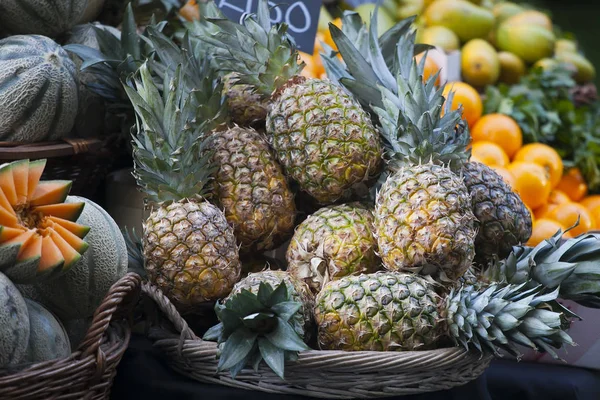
203 282 310 379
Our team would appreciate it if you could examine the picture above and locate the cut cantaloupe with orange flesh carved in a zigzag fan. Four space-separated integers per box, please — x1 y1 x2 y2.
0 160 89 283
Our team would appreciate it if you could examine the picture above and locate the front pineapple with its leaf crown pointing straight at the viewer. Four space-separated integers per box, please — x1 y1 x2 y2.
203 271 314 379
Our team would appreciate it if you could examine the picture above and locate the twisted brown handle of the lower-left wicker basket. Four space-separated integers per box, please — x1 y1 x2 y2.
77 272 142 358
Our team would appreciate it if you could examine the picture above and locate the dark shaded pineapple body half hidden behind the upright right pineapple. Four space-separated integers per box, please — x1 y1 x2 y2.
461 162 532 265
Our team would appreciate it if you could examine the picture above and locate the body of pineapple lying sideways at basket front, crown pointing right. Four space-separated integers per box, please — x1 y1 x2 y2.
315 271 440 351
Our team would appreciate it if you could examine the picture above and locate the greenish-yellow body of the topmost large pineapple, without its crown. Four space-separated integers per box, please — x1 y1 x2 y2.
266 79 382 204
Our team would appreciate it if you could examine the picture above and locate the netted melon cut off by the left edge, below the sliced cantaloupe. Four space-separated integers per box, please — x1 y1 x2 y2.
0 273 29 368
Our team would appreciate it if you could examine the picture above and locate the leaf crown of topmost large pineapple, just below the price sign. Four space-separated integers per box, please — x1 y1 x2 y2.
193 0 304 97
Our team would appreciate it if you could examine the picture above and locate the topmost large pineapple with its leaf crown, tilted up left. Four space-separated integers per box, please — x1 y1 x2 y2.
199 0 382 204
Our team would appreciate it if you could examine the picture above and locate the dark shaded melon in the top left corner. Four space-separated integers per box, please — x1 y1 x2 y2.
0 0 88 37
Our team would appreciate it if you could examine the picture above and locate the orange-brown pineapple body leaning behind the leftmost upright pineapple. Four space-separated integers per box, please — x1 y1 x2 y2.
213 127 296 254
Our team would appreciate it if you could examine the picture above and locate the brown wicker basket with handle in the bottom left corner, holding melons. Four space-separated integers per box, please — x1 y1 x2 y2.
0 273 141 400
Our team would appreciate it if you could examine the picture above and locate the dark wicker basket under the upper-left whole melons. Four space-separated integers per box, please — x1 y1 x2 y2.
0 139 117 200
